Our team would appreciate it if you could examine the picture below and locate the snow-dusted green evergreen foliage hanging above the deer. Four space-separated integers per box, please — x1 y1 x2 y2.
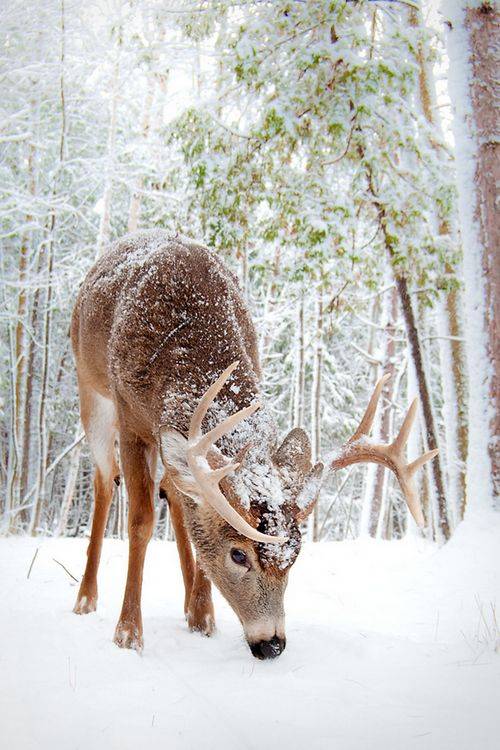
175 2 455 300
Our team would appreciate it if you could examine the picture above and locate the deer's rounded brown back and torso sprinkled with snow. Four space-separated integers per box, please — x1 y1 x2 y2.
72 230 260 433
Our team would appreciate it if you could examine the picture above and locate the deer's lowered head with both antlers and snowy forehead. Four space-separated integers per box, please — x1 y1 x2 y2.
159 362 436 659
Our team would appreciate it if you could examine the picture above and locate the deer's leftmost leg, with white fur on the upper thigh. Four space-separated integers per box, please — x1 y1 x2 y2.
73 387 119 615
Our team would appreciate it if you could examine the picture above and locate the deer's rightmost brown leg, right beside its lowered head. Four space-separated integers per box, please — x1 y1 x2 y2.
160 474 215 635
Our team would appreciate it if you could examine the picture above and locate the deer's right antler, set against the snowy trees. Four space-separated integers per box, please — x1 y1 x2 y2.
330 374 439 527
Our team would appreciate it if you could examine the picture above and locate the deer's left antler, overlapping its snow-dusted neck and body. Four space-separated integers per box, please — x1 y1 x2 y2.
186 362 286 544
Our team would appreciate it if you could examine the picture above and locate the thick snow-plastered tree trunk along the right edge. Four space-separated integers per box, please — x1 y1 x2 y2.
447 0 500 507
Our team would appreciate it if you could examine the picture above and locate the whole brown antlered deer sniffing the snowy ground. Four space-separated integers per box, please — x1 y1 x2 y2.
71 229 437 659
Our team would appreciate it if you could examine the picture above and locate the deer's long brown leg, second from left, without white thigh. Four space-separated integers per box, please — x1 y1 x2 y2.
114 434 154 651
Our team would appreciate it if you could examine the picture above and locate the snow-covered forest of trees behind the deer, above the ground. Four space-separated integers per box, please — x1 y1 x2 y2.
0 0 499 540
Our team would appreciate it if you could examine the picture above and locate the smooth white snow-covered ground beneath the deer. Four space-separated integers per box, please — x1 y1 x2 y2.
0 515 500 750
